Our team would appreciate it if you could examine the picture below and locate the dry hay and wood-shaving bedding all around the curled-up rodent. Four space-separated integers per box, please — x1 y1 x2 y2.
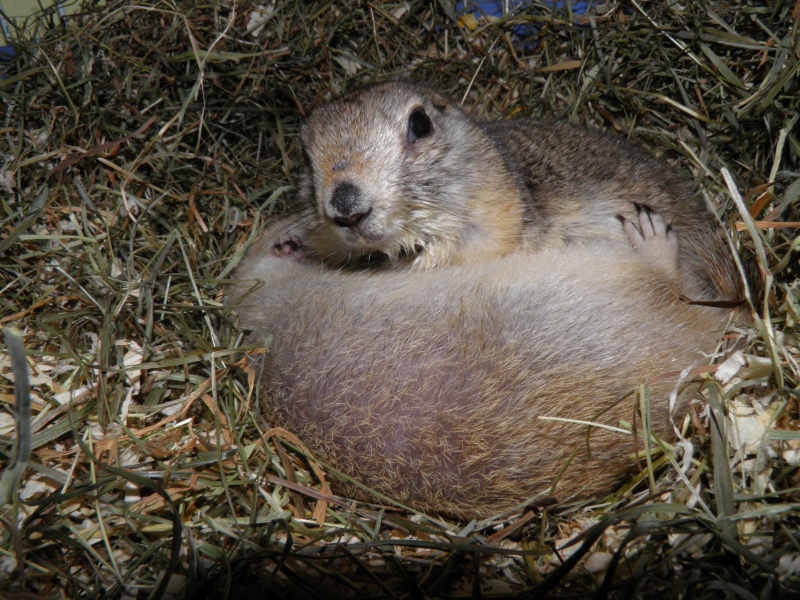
0 0 800 598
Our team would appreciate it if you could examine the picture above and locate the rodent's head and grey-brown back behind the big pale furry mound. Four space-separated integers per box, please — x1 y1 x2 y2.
290 82 738 300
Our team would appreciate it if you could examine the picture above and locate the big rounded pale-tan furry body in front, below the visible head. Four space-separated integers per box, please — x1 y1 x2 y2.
235 211 727 518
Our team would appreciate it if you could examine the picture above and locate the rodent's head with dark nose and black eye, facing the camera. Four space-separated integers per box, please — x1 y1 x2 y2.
301 82 491 263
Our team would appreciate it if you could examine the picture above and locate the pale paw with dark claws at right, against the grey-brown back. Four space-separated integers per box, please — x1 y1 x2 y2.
617 203 679 277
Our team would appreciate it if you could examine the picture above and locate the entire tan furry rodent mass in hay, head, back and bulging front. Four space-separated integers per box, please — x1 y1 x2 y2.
231 83 738 518
